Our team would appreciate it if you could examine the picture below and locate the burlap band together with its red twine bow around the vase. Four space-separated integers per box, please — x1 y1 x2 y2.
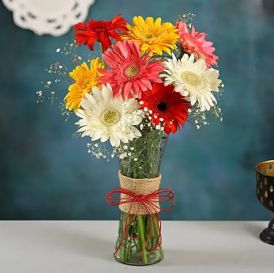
105 172 174 254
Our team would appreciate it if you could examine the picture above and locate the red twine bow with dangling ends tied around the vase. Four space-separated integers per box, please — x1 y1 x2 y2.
105 188 174 254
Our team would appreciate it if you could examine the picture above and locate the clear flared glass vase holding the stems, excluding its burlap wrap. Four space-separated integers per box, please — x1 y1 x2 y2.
114 129 167 265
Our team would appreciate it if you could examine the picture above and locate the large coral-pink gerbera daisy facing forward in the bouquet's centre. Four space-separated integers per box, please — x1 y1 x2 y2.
99 41 164 98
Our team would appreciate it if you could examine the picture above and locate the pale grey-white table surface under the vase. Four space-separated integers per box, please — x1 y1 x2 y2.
0 221 274 273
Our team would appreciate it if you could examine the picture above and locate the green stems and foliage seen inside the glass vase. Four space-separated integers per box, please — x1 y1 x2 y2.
119 128 167 264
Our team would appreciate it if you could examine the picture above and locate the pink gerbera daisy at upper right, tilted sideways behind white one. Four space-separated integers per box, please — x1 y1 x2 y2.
176 21 218 67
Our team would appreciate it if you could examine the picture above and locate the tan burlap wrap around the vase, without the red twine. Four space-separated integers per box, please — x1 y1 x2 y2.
119 172 161 214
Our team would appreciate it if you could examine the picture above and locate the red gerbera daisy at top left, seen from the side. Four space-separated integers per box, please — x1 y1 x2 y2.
74 15 127 51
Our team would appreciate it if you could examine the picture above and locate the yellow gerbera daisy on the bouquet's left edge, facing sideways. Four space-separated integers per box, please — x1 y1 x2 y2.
65 58 104 111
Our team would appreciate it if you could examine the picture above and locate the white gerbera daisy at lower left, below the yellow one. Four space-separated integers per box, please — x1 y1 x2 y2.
75 84 143 147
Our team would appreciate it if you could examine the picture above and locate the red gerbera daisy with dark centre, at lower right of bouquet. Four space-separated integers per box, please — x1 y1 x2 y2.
138 83 191 134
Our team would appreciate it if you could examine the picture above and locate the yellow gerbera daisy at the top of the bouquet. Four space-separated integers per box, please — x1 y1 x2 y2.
122 16 179 56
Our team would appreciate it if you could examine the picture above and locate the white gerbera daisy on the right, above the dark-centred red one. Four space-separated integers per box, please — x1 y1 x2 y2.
162 54 221 111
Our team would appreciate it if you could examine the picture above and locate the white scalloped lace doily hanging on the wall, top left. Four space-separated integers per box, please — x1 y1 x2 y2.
3 0 95 36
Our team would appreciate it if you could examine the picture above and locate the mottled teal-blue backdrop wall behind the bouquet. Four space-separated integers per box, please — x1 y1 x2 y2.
0 0 274 219
